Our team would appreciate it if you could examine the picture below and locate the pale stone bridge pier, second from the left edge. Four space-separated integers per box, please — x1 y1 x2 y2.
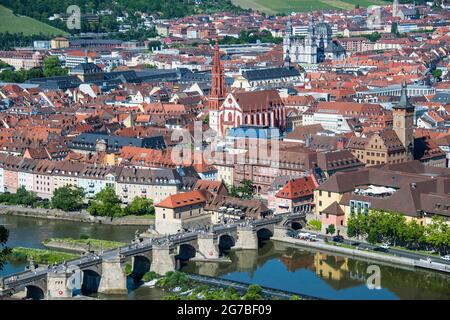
98 256 128 294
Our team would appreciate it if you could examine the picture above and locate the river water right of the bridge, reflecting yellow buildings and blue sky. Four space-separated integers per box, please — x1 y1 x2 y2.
182 241 450 299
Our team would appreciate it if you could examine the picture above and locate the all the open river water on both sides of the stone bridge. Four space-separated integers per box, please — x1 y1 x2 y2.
0 216 450 299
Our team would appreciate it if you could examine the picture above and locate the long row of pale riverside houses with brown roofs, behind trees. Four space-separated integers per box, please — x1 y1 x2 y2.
0 154 198 203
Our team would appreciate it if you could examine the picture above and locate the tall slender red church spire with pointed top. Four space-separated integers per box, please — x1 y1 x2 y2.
208 35 226 110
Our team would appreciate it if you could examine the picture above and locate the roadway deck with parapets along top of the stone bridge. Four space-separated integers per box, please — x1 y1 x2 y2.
0 213 305 296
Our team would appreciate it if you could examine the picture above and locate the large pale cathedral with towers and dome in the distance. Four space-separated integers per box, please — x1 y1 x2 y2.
283 16 345 64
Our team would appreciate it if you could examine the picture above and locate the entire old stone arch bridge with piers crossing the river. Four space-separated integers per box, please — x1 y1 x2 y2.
0 214 305 299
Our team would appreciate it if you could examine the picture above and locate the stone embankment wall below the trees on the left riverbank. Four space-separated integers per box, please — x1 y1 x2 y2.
0 205 155 227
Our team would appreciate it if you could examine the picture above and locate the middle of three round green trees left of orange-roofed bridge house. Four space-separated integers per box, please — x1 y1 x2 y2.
87 186 123 217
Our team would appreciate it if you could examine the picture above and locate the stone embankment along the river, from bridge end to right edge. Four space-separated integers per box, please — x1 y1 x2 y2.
272 237 450 273
